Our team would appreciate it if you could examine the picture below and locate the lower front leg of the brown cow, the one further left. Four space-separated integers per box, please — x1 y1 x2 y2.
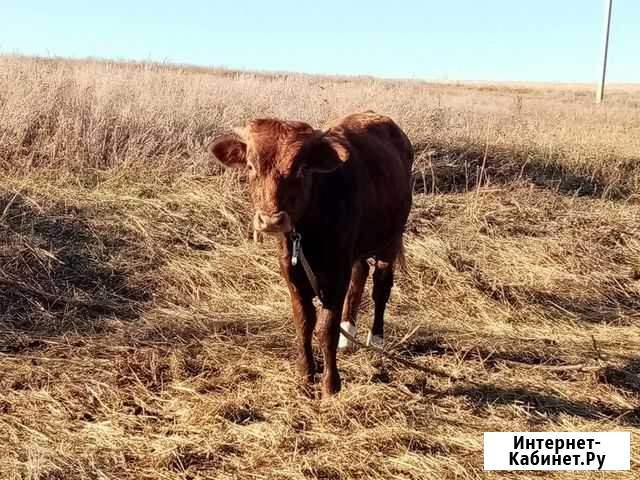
289 287 316 384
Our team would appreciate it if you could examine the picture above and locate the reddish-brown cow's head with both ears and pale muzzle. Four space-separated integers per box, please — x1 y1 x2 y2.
208 119 349 234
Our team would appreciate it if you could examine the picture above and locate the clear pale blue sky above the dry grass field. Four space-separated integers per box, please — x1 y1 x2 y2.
0 0 640 83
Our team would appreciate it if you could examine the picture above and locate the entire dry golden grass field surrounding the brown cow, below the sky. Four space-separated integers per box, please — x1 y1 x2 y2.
0 56 640 480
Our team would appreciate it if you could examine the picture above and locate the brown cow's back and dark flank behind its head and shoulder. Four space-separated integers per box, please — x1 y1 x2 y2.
328 112 413 257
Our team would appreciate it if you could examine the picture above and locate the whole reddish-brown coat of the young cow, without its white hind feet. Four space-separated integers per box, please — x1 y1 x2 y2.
209 112 413 394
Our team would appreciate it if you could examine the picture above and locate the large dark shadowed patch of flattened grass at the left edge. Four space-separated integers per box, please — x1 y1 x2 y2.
0 194 148 335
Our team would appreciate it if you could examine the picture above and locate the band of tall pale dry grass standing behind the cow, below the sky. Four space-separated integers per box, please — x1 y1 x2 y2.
0 56 640 196
